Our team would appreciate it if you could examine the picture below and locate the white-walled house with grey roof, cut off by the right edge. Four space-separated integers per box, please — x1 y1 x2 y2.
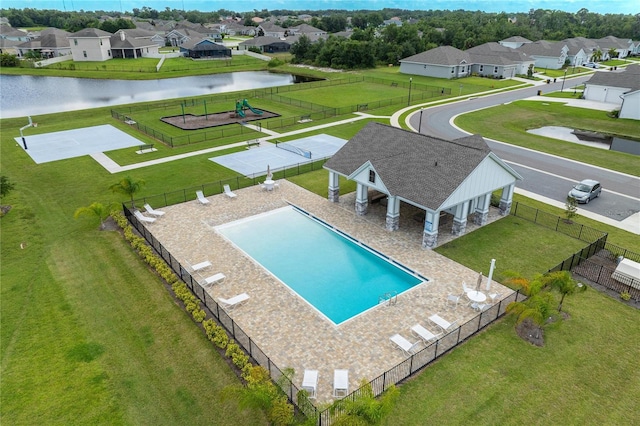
583 64 640 120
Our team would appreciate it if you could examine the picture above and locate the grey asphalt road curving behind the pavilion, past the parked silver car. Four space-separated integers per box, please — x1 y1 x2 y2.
410 76 640 229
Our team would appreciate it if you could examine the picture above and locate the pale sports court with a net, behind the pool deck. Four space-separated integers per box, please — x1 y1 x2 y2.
209 134 347 177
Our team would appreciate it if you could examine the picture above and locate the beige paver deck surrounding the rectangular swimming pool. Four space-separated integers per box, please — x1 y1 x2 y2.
147 180 512 403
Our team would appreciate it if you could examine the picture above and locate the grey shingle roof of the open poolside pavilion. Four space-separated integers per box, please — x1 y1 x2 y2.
325 122 497 210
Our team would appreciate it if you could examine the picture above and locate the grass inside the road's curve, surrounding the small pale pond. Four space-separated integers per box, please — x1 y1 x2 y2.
455 101 640 176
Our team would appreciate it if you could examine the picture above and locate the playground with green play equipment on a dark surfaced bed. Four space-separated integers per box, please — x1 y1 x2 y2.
160 99 280 130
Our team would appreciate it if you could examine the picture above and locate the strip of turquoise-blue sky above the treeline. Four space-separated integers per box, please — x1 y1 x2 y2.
0 0 640 15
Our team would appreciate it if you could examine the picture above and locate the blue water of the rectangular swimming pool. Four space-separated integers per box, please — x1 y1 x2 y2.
216 207 426 324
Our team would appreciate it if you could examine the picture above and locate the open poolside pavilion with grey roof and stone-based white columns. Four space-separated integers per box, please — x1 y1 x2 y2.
323 122 522 248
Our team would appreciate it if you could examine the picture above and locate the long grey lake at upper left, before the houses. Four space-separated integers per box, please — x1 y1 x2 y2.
0 71 296 118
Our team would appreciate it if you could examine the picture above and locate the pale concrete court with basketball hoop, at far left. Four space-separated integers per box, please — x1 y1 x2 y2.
15 124 143 164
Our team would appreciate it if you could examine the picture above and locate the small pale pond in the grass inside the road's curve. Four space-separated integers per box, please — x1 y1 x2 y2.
527 126 640 155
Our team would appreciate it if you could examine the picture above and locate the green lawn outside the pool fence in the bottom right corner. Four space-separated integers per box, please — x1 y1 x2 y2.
383 290 640 426
